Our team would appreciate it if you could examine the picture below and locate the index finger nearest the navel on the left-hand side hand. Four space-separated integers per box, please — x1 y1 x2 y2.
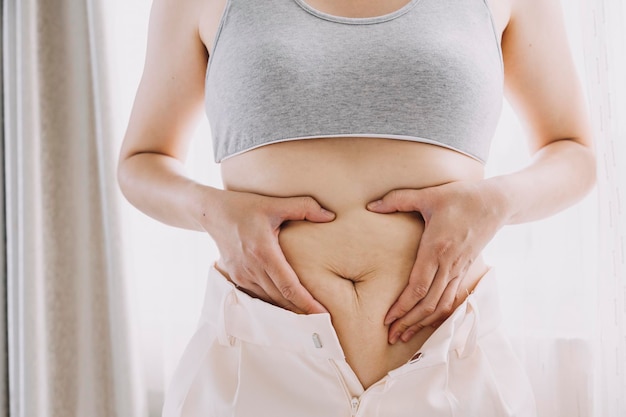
265 245 328 314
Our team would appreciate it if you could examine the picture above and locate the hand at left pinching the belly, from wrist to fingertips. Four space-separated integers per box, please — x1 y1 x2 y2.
201 191 335 314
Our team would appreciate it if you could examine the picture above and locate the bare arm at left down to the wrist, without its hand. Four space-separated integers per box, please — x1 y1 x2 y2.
118 0 211 230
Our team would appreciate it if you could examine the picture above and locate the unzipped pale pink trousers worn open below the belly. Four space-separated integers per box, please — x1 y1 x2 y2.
163 269 536 417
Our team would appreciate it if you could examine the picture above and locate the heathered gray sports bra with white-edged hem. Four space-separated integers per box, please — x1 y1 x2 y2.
205 0 503 162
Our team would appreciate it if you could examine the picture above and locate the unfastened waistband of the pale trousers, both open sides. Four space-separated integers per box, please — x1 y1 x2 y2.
200 267 501 359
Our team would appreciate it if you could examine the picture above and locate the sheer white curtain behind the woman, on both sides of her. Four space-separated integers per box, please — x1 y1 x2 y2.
108 0 626 417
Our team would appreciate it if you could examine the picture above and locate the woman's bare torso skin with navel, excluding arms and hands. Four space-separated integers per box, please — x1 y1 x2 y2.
200 0 510 387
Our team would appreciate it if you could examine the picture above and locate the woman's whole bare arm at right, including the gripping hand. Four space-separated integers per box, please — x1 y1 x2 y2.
368 0 596 343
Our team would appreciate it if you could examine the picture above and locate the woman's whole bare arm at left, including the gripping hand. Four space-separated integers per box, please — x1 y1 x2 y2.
118 0 334 313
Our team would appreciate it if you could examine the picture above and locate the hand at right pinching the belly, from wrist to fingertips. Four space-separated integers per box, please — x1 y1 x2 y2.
367 180 505 344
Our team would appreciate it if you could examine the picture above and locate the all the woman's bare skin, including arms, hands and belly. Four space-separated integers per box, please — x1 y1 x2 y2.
119 0 595 387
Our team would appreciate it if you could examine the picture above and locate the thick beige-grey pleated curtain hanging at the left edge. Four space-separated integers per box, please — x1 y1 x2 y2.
4 0 145 417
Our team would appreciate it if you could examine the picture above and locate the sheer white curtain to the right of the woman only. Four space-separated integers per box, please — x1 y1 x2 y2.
482 0 626 417
